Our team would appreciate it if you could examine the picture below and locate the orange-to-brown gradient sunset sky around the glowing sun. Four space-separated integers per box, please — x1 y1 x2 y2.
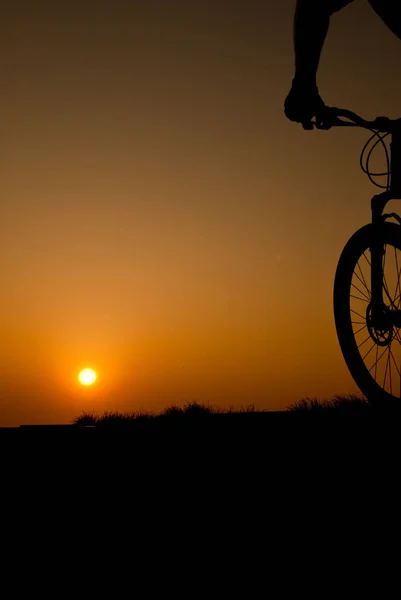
0 0 401 425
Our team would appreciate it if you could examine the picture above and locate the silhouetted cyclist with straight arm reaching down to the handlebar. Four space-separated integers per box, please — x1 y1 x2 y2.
284 0 401 129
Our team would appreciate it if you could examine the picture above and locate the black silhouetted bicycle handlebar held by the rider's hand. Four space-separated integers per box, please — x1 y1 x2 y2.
312 107 401 133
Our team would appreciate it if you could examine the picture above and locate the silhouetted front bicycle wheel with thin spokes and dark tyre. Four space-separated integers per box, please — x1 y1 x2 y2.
334 223 401 404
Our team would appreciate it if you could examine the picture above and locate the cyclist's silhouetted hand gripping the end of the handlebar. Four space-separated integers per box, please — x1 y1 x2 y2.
284 81 328 129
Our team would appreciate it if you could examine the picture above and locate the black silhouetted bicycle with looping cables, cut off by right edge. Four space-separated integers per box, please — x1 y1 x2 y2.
313 108 401 405
